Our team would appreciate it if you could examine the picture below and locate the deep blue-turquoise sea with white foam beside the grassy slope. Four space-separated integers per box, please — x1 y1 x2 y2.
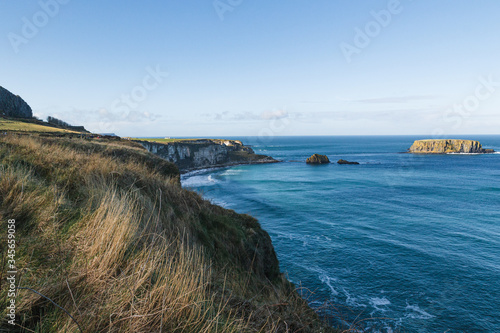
182 136 500 332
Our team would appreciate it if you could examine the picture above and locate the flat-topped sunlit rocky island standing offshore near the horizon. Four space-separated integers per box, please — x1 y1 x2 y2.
409 139 492 154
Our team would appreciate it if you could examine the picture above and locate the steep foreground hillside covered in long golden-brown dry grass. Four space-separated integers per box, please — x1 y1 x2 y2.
0 134 338 333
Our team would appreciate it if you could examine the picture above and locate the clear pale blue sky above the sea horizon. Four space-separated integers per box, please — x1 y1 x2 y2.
0 0 500 136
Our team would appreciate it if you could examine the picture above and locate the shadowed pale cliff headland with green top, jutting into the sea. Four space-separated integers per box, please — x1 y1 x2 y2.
138 139 278 172
